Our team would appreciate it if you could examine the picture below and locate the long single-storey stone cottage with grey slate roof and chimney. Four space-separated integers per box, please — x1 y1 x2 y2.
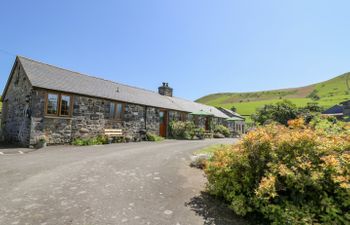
1 56 238 146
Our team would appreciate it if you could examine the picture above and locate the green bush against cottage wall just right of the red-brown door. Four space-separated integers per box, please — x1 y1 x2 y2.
169 121 196 140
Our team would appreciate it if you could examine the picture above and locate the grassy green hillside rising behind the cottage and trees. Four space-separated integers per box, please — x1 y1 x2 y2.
196 73 350 116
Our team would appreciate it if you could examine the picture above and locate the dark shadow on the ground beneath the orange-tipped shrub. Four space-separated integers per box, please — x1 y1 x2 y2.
185 192 249 225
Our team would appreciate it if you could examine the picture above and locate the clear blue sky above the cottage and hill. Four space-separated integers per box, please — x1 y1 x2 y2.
0 0 350 100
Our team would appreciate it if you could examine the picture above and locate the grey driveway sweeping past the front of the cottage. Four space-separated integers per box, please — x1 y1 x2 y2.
0 139 244 225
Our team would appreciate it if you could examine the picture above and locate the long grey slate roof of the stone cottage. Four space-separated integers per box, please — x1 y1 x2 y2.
4 56 228 118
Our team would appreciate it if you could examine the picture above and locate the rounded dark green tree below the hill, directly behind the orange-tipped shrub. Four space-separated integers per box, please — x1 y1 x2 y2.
252 100 299 125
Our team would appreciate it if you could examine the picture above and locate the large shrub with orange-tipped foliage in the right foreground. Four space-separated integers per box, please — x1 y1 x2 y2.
205 119 350 224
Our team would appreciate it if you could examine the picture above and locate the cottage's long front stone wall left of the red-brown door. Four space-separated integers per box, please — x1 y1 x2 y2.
30 90 159 145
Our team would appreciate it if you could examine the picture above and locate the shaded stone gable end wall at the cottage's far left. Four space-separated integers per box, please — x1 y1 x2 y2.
1 63 32 146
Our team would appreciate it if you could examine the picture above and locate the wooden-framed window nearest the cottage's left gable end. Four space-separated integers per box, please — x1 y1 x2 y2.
46 93 72 116
